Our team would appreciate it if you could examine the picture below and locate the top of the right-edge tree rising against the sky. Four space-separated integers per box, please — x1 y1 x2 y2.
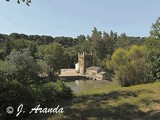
150 17 160 39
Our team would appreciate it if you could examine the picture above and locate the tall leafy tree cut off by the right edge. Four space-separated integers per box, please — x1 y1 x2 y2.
145 17 160 80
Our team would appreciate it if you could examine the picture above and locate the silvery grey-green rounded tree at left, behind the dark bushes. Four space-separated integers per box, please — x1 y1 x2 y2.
8 49 40 83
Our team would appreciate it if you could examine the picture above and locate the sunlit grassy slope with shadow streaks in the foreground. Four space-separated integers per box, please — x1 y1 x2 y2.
29 82 160 120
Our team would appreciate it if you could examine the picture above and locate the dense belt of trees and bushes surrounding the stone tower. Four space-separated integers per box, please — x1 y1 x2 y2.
0 18 160 117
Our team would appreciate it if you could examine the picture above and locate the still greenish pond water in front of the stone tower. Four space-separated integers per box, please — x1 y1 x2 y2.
65 80 108 93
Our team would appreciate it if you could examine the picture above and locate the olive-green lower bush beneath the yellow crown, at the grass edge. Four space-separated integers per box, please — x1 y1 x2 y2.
115 59 152 86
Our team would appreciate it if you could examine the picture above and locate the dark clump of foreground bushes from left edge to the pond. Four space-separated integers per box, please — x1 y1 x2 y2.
0 79 73 120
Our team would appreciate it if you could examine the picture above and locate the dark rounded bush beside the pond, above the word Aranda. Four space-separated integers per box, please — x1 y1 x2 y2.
37 80 73 105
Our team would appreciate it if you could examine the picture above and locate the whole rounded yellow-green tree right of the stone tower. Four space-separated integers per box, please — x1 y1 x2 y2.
107 45 153 86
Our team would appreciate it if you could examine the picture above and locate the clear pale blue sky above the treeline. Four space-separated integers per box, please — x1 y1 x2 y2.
0 0 160 37
